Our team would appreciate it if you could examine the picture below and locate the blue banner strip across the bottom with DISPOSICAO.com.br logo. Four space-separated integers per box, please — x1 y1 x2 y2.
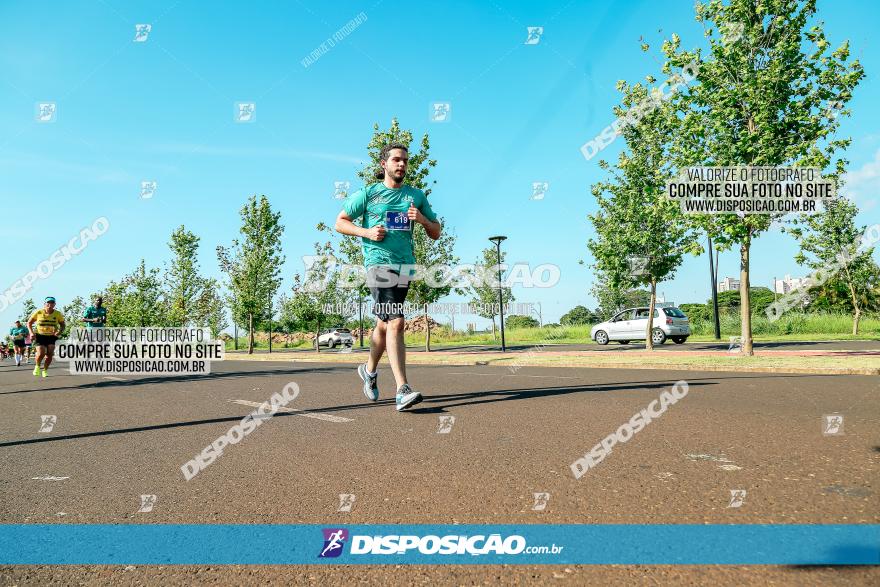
0 524 880 565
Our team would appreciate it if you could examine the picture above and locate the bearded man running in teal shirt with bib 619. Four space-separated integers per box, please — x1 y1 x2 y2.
336 144 442 412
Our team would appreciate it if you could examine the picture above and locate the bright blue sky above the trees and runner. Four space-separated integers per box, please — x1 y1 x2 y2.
0 0 880 322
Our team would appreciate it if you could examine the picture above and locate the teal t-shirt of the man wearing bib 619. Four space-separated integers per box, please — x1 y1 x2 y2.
342 183 437 267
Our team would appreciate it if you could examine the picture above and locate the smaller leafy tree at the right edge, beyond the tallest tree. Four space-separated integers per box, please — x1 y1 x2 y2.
789 198 877 334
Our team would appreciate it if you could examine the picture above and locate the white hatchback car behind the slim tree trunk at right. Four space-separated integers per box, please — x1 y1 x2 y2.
590 306 691 344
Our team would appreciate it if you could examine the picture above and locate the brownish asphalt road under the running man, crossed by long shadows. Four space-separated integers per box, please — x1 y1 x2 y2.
0 360 880 585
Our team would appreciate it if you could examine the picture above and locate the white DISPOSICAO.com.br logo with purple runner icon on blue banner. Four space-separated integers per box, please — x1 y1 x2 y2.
318 528 564 558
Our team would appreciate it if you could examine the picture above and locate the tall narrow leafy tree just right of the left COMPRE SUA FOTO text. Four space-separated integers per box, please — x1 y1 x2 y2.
217 196 284 354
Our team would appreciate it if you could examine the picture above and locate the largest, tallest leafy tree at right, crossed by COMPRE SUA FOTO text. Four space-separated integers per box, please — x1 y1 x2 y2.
663 0 864 355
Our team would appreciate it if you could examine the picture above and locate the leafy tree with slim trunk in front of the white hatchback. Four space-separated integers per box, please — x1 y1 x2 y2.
588 77 700 350
